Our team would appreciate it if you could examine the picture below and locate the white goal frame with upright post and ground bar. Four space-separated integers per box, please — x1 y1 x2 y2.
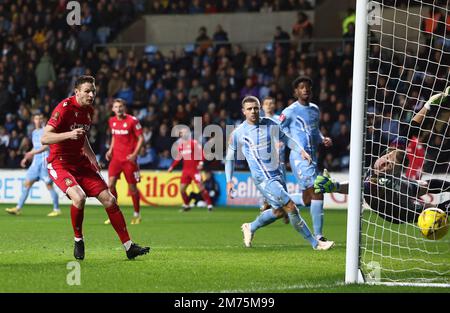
345 0 450 287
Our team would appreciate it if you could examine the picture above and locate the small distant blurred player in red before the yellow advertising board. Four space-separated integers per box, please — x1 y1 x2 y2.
168 128 213 211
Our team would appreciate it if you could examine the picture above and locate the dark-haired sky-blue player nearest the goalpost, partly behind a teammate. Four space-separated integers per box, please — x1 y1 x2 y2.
280 77 333 241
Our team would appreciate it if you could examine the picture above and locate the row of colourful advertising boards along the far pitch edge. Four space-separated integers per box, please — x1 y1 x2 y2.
0 170 446 209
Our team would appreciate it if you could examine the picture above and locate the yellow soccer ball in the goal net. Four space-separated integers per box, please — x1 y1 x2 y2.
417 208 448 240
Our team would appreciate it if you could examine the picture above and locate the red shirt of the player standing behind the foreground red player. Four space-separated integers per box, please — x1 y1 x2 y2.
109 114 142 161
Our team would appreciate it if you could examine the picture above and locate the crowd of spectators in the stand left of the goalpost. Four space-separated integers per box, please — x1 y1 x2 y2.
0 0 353 170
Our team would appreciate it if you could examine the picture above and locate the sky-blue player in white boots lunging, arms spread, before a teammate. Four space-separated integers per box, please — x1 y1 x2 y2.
225 96 334 250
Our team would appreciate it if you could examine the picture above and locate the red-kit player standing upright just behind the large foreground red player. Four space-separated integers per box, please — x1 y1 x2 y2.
105 98 144 225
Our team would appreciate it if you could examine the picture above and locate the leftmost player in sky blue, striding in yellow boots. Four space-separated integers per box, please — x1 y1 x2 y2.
5 113 61 217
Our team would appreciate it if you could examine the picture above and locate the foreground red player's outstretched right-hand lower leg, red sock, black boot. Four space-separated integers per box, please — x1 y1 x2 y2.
97 189 150 260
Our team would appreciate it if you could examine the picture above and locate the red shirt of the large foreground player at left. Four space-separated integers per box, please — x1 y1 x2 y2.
47 96 94 163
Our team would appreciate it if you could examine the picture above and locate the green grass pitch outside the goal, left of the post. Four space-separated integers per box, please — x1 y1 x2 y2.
0 205 449 292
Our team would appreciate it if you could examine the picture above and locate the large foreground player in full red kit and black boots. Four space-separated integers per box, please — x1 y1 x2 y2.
41 76 150 260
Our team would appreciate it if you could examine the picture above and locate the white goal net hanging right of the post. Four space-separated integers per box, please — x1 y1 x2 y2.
359 0 450 286
